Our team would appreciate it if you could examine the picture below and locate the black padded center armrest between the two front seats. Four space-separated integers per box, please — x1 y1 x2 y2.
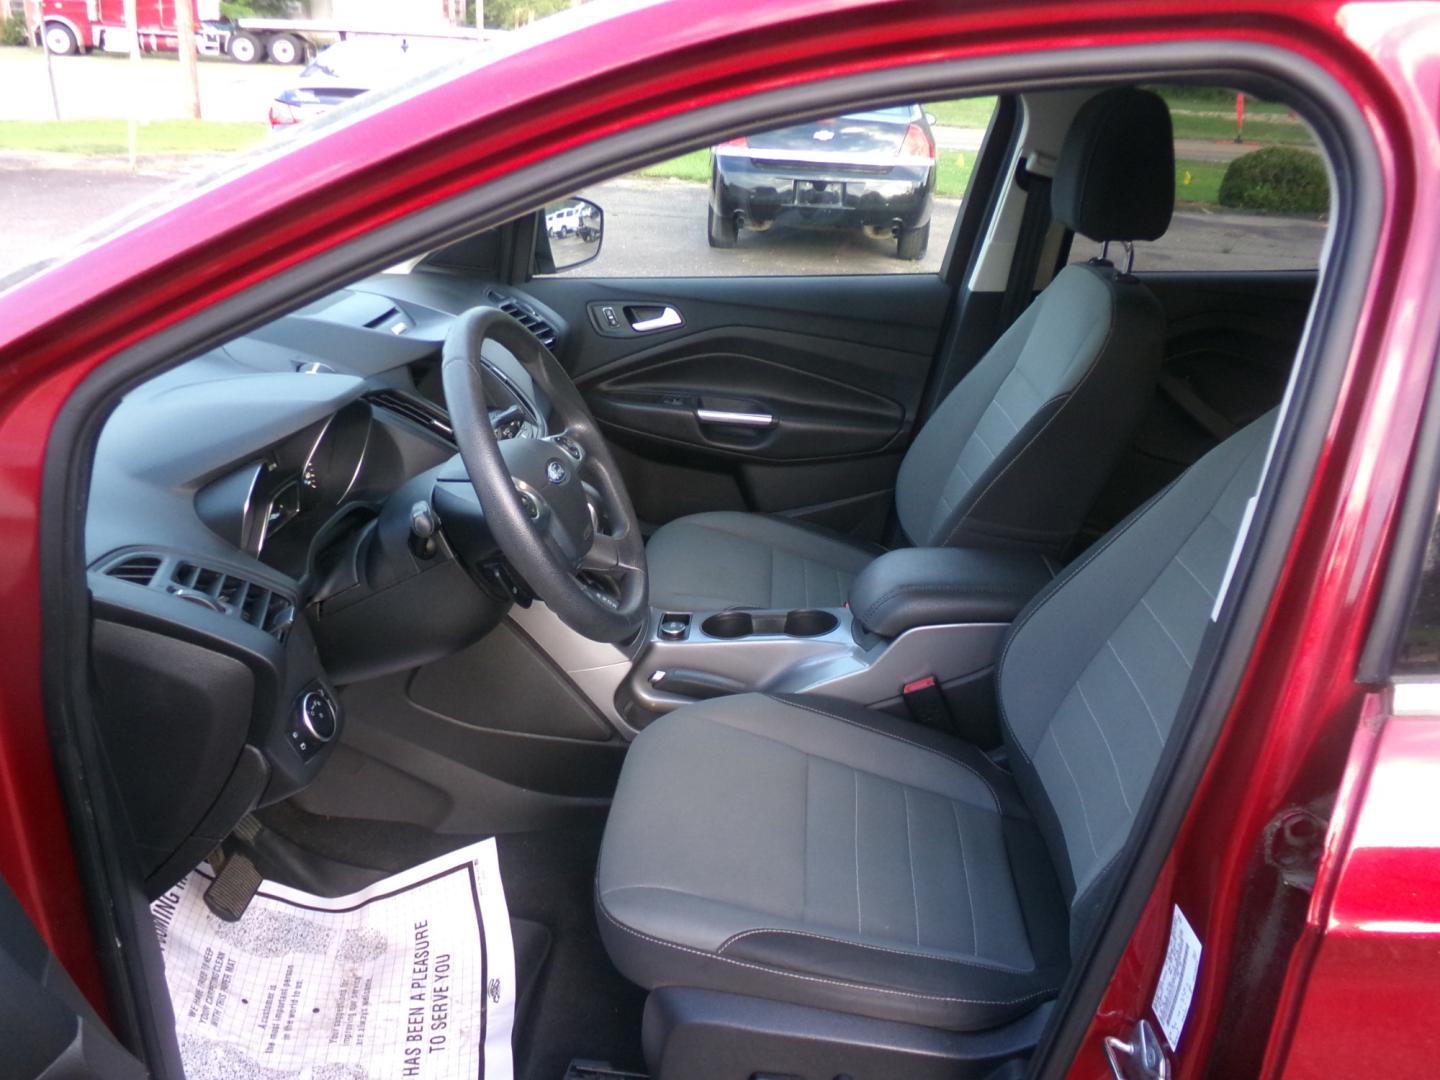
850 547 1054 638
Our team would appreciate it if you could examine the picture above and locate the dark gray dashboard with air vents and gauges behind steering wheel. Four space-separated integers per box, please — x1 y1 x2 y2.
85 269 564 894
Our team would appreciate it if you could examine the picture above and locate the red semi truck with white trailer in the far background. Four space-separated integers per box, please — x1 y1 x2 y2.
27 0 485 63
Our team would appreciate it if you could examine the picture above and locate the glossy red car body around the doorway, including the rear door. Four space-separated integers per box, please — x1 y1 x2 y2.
0 0 1440 1077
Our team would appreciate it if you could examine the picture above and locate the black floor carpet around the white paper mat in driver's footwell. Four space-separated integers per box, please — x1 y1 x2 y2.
256 804 645 1080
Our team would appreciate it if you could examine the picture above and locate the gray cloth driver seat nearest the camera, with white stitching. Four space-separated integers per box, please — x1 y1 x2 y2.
596 418 1273 1031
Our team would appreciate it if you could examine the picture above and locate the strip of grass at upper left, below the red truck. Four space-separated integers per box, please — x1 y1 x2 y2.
0 120 269 154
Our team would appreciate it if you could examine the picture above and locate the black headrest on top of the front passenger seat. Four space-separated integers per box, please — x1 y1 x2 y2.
1050 86 1175 242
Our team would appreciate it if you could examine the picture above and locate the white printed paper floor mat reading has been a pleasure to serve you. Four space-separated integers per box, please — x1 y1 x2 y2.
151 840 515 1080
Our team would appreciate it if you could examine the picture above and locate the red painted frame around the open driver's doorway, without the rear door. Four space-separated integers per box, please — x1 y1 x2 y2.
0 0 1440 1076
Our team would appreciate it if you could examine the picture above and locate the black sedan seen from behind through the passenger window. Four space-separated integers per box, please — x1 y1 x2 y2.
707 105 935 259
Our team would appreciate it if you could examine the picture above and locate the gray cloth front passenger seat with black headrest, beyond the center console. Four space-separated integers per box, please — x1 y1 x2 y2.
647 89 1175 611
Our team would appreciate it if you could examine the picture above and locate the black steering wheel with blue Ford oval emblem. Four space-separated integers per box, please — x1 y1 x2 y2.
441 307 649 642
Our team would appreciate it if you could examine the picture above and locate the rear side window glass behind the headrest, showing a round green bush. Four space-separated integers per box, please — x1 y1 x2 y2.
1070 86 1329 272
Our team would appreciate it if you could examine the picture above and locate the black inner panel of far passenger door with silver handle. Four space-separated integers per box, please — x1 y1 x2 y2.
527 274 949 539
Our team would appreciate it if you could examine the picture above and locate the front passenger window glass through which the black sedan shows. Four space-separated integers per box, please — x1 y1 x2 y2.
547 98 995 278
